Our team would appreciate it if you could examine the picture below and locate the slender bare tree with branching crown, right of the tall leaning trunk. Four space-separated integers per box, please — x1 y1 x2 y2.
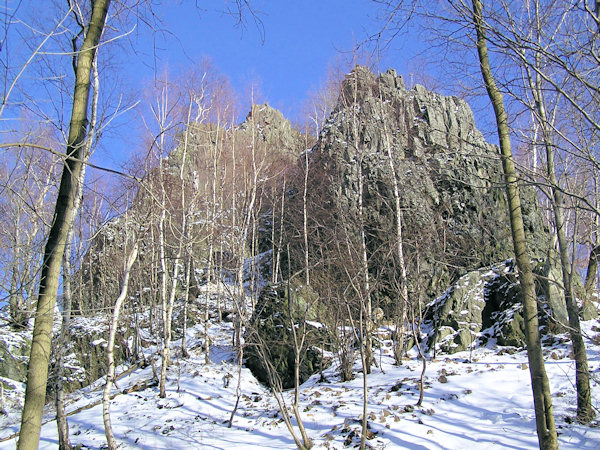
476 2 598 423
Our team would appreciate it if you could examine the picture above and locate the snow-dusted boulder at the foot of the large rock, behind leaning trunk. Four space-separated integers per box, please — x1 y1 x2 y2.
425 260 585 353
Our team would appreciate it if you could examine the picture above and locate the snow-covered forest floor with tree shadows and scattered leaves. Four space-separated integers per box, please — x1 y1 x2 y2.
0 312 600 450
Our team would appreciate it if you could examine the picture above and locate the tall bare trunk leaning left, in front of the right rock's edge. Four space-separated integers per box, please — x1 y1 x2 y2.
473 0 558 449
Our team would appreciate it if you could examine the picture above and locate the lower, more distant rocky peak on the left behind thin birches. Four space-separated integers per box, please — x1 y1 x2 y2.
74 103 307 314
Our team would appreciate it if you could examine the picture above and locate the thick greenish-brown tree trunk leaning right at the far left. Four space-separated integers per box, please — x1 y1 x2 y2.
18 0 110 450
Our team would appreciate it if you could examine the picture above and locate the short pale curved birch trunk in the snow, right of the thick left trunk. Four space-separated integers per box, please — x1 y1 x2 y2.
102 241 138 450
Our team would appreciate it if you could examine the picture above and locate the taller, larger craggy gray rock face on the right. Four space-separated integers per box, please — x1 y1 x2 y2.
309 67 547 301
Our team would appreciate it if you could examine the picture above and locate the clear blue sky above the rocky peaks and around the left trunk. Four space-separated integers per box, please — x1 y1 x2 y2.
0 0 417 168
